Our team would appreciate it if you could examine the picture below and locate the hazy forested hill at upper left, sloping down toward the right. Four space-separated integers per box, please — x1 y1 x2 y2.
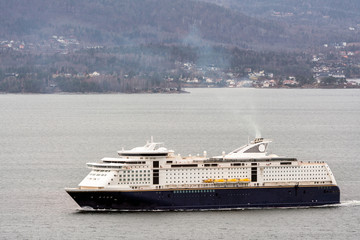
0 0 298 48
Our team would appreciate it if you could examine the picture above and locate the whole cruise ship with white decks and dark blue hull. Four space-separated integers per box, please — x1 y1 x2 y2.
65 138 340 211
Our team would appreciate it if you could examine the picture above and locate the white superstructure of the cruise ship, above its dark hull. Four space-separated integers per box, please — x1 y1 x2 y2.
79 138 336 190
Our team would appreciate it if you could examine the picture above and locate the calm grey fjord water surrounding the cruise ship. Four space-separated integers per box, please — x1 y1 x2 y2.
0 89 360 239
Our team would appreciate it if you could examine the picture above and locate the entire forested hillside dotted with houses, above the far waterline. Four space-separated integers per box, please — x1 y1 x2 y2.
0 0 360 93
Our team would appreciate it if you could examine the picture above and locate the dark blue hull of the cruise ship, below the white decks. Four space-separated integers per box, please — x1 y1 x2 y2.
66 186 340 210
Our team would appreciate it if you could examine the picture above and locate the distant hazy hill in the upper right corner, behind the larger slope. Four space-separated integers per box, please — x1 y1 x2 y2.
199 0 360 46
